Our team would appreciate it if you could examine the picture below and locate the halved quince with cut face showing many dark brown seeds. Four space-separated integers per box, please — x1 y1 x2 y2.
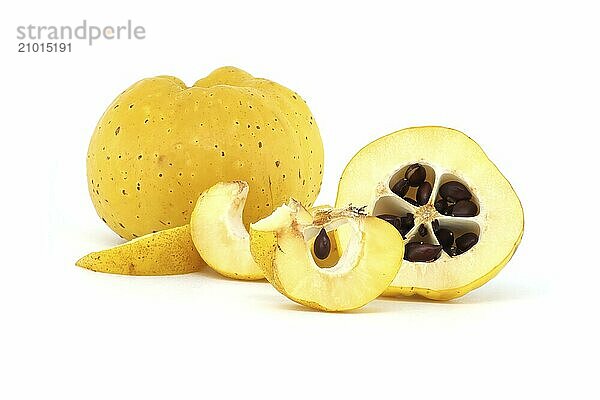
336 127 523 300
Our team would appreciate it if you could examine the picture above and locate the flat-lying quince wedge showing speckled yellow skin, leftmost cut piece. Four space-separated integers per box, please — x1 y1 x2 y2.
75 225 205 275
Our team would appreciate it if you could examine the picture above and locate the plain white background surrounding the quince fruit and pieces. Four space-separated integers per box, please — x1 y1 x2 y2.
0 0 600 399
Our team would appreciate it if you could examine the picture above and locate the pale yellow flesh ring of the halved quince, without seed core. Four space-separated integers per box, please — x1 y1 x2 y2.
336 127 523 300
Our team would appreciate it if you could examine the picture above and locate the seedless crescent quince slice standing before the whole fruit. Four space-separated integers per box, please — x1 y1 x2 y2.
190 181 264 280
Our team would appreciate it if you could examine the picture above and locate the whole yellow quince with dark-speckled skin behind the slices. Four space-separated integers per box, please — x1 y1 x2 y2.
87 67 323 239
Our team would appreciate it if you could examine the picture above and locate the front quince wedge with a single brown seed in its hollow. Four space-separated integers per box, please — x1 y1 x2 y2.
250 199 404 311
